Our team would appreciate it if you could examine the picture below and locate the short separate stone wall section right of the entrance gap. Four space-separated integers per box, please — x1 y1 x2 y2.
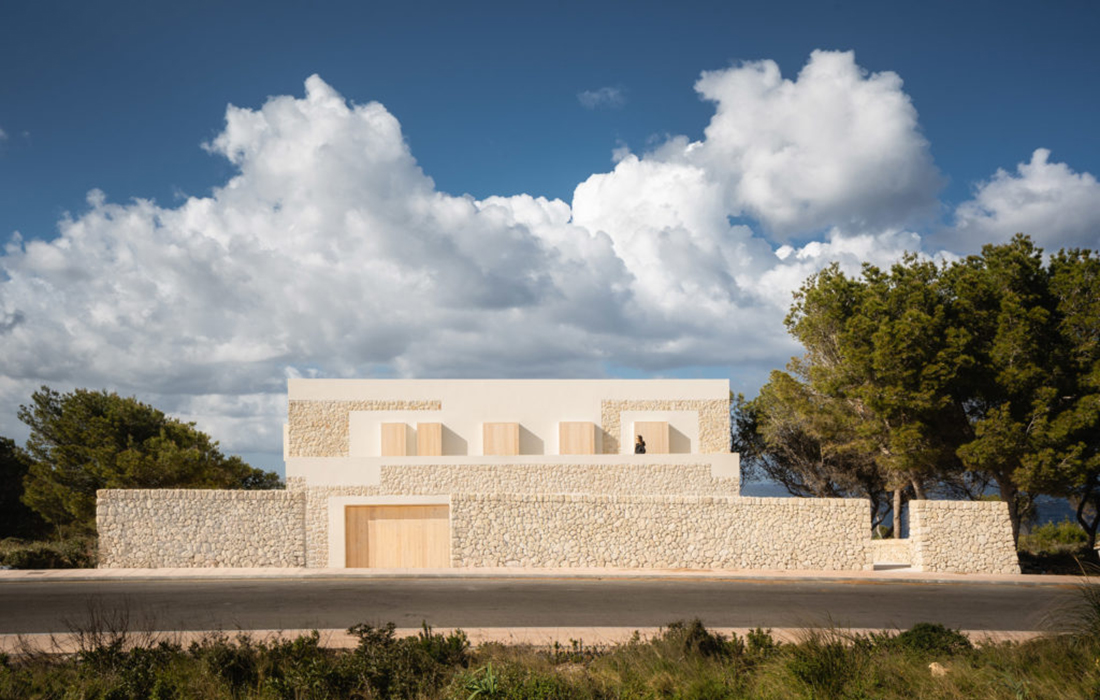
909 501 1020 573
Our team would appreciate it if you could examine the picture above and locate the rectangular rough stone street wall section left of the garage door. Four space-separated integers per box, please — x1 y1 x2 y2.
96 489 306 568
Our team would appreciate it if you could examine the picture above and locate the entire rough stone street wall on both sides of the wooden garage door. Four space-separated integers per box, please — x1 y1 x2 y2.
96 488 1020 573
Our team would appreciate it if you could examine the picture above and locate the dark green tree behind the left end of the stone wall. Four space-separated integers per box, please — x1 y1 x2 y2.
19 386 281 531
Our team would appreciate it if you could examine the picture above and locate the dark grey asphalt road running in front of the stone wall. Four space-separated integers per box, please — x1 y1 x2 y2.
0 579 1077 634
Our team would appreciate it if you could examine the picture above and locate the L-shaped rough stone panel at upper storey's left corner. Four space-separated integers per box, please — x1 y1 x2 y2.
287 400 442 457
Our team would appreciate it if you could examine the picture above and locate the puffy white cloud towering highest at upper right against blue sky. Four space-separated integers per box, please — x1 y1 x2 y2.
693 51 942 237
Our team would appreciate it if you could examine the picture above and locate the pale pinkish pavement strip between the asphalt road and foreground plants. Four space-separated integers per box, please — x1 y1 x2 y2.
0 627 1045 655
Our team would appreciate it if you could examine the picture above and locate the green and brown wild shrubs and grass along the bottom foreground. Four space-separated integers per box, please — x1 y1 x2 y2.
0 616 1100 700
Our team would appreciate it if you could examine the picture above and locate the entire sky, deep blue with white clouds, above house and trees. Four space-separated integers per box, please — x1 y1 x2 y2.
0 1 1100 471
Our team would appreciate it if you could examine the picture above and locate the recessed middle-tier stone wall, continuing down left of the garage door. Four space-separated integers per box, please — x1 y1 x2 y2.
287 462 739 567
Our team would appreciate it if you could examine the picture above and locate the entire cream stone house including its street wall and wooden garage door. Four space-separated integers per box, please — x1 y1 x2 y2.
97 379 1019 573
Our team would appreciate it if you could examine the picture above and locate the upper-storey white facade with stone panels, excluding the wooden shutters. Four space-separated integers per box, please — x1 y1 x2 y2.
284 379 729 458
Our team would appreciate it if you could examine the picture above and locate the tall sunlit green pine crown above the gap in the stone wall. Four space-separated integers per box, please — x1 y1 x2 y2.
787 256 969 497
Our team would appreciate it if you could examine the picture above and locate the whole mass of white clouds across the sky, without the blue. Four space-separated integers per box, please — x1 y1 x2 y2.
0 52 1096 462
